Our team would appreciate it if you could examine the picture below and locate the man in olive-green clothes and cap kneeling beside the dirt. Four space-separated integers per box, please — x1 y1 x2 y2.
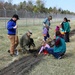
20 30 35 52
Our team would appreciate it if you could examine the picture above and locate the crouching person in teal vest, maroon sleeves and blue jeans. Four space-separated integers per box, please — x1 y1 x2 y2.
45 31 66 59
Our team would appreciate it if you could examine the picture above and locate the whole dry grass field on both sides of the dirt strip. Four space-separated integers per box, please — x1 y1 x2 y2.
0 20 75 75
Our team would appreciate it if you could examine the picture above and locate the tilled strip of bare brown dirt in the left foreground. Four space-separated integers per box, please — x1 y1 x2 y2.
0 55 43 75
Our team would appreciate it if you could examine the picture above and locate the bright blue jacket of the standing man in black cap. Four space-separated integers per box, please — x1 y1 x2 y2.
7 19 16 35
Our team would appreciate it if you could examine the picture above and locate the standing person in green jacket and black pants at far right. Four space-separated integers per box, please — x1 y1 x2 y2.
63 17 70 42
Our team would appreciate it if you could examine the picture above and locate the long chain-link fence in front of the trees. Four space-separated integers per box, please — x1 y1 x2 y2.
0 8 75 27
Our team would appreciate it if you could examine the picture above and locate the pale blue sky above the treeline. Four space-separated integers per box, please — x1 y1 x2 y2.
5 0 75 12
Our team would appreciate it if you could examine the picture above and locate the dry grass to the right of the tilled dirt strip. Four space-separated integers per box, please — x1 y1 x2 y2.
28 35 75 75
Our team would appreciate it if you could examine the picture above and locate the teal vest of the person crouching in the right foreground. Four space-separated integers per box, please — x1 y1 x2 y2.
54 36 66 53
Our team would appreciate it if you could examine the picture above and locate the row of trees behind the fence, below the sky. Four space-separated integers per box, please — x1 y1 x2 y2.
0 0 75 14
